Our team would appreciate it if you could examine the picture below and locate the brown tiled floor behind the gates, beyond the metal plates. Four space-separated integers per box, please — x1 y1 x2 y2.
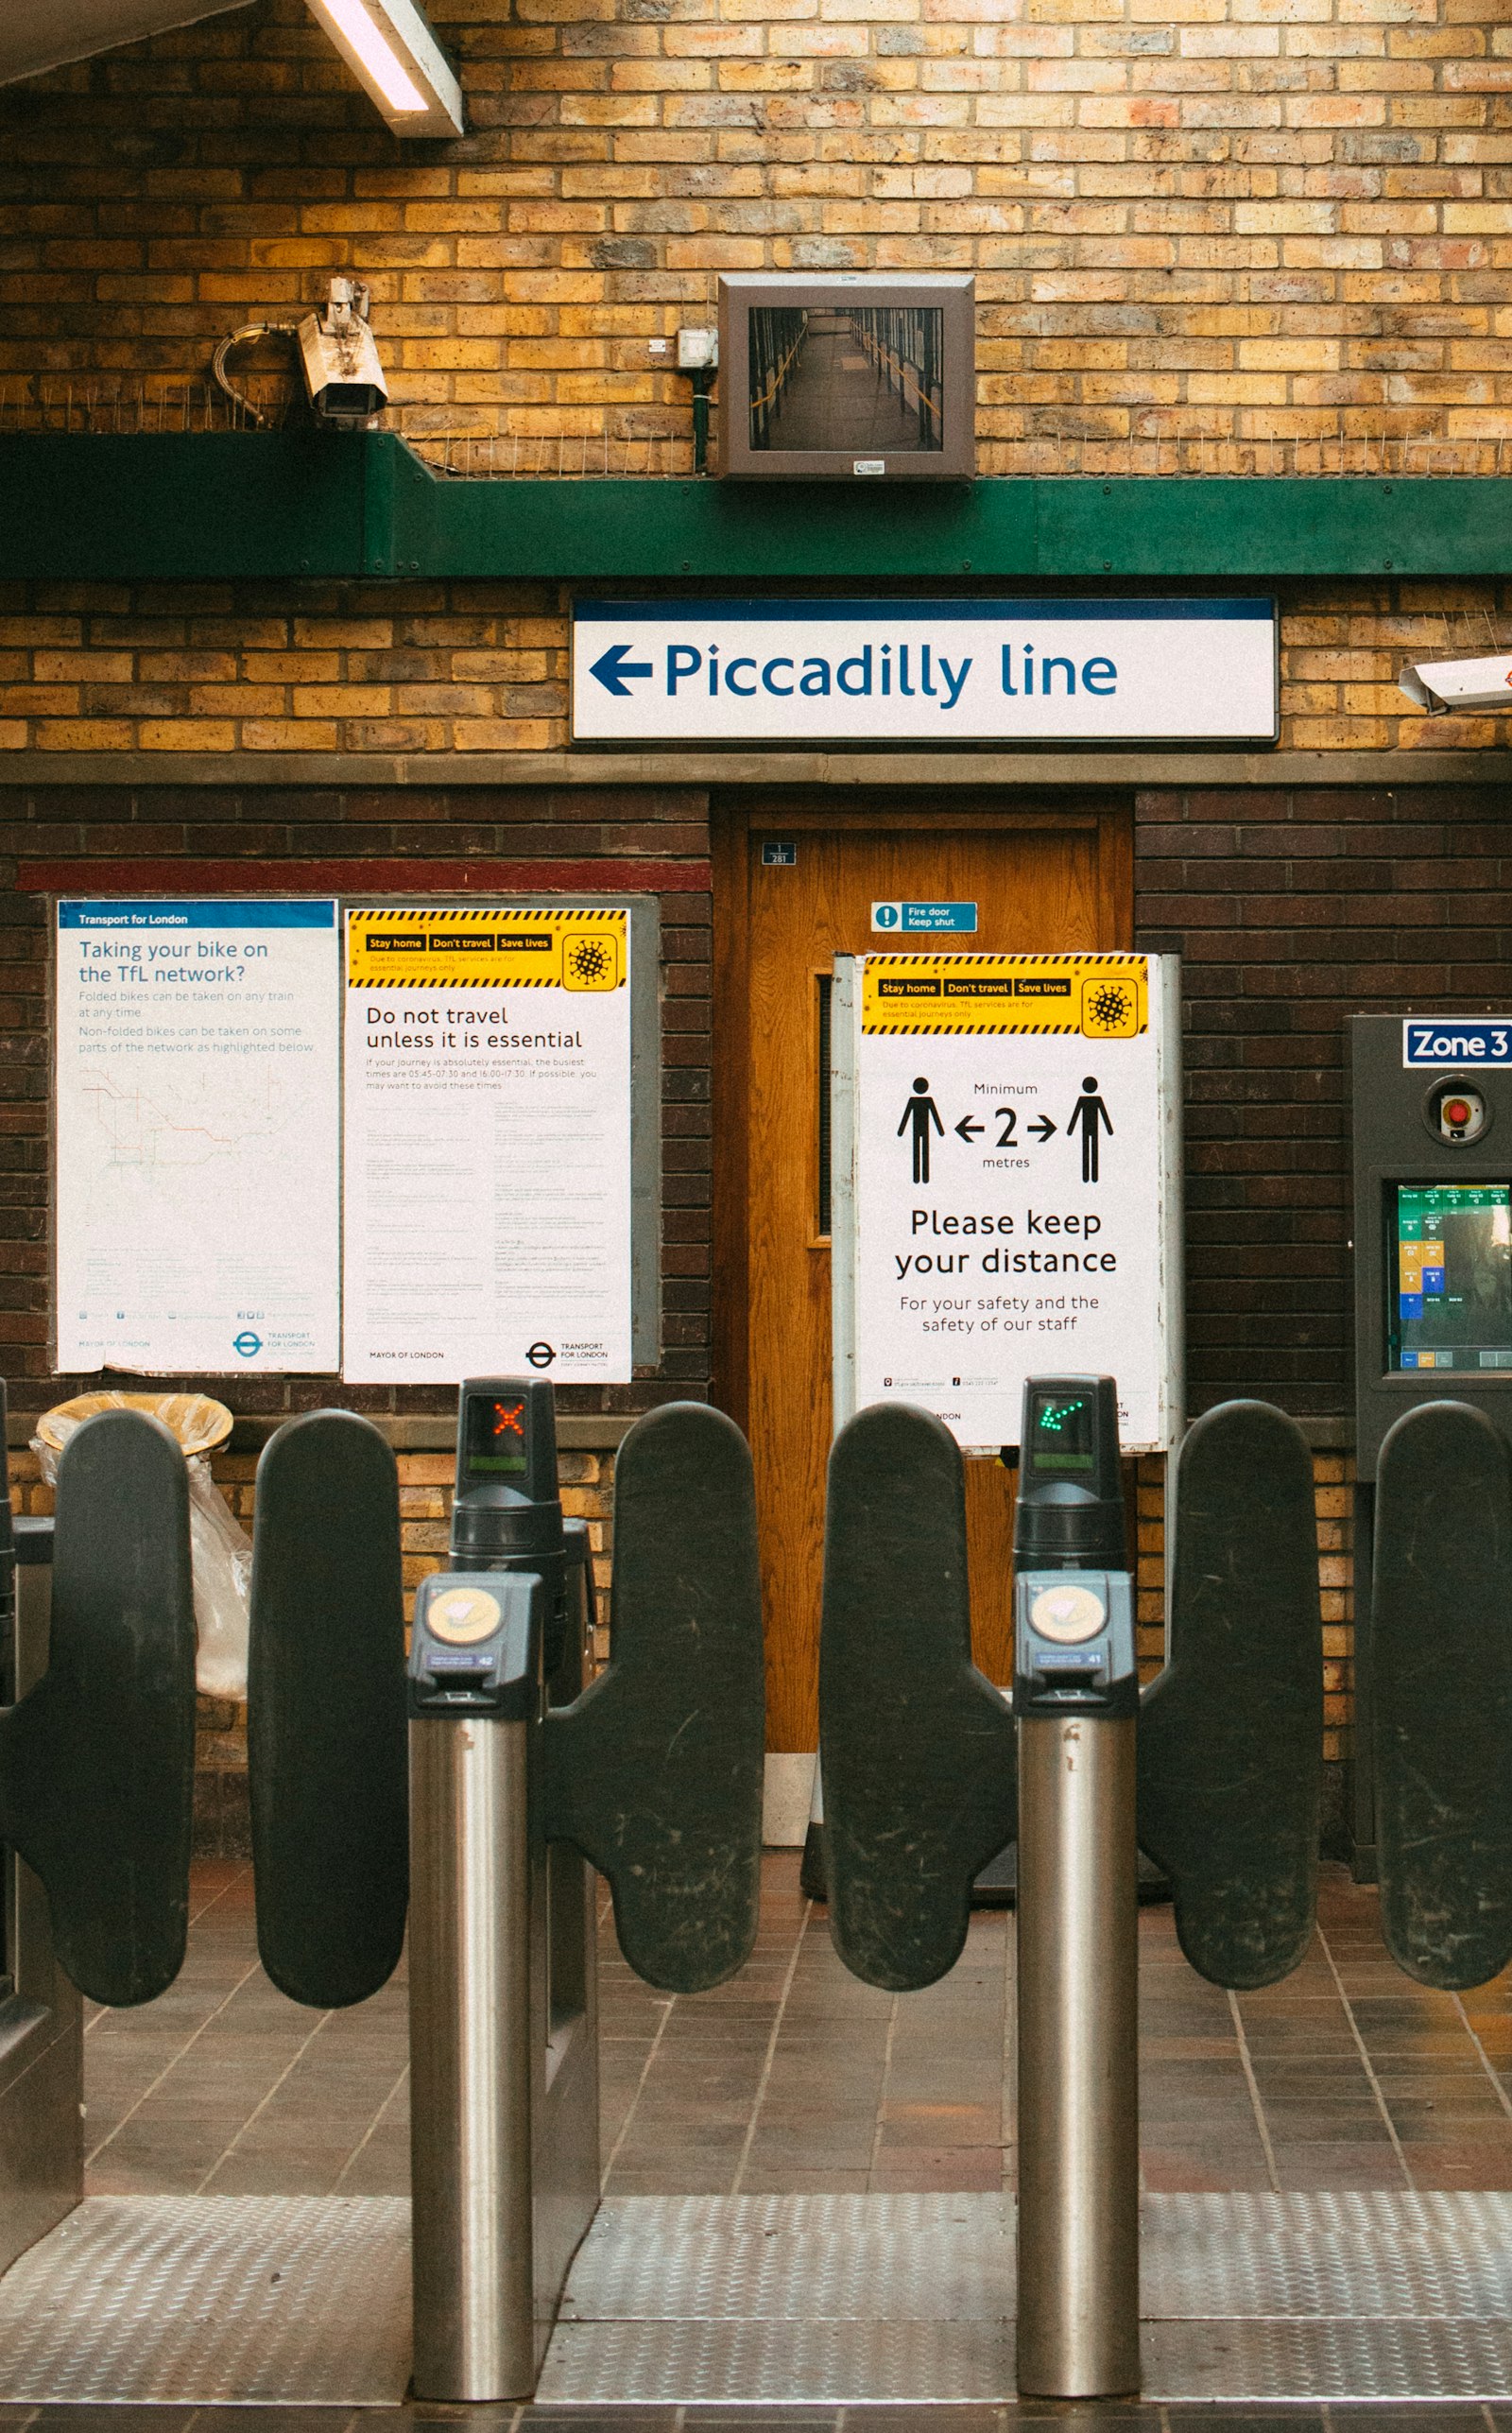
85 1854 1512 2218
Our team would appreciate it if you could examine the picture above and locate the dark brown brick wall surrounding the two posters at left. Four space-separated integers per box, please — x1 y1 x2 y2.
0 785 713 1413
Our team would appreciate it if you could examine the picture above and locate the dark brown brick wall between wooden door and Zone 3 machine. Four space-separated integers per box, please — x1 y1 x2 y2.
1135 785 1512 1413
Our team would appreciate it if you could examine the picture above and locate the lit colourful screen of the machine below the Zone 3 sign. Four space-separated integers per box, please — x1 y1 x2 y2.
1385 1182 1512 1374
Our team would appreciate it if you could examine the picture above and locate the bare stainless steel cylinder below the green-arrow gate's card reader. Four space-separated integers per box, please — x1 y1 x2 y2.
1019 1716 1140 2399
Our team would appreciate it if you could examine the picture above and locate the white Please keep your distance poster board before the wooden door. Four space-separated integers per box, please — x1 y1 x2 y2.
832 954 1181 1450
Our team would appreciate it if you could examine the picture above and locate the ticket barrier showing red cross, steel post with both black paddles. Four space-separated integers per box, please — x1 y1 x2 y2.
248 1377 764 2402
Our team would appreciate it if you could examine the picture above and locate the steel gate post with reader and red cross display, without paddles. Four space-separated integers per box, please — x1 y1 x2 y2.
408 1377 598 2402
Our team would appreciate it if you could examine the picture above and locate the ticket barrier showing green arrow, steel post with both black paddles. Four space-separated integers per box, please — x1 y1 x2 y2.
819 1377 1322 2399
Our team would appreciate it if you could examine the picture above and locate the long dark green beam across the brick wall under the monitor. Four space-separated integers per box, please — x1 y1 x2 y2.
11 431 1512 584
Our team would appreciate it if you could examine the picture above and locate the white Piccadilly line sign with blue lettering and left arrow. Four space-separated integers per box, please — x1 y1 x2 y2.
572 598 1279 745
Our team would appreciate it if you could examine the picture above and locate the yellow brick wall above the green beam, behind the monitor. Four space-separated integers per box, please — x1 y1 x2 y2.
0 0 1512 457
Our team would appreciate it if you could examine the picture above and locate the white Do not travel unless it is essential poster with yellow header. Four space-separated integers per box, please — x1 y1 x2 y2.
343 906 632 1385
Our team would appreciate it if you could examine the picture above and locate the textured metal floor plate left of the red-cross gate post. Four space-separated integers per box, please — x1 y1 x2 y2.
0 2197 411 2407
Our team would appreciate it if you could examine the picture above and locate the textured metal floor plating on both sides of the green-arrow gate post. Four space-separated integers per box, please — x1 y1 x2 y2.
540 2192 1512 2404
